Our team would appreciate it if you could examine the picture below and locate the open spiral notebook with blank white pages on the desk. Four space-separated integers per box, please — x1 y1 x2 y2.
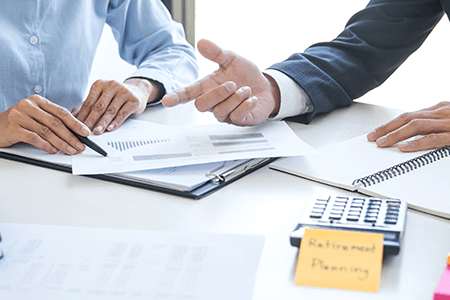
270 135 450 219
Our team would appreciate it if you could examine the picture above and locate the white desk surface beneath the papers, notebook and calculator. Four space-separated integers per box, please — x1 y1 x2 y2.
0 103 450 300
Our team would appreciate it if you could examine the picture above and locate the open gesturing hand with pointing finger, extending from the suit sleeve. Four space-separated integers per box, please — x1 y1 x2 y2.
162 40 280 126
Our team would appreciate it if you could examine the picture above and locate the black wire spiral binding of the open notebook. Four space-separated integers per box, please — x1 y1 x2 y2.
352 146 450 187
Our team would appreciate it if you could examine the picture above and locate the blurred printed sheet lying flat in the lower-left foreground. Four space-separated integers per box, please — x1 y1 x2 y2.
0 224 264 300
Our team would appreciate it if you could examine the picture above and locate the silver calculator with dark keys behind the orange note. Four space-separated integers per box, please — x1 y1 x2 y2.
291 195 408 255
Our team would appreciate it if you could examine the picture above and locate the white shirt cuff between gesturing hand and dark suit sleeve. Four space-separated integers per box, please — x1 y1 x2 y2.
264 69 314 120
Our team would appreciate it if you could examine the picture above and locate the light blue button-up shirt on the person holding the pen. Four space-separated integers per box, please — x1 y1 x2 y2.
0 0 198 112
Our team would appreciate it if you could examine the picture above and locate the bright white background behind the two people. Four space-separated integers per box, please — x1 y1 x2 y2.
90 0 450 110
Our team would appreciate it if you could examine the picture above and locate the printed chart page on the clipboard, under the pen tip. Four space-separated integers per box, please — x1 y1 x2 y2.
72 121 316 175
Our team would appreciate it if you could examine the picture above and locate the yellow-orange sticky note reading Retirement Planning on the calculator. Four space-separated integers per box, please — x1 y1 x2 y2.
295 228 383 292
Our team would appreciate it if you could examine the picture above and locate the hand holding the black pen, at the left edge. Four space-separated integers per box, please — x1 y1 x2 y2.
0 95 90 155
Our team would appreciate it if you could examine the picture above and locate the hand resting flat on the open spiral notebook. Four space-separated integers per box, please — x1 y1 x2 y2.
367 102 450 152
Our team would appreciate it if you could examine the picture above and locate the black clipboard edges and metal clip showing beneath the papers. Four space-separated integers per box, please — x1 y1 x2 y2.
0 150 277 200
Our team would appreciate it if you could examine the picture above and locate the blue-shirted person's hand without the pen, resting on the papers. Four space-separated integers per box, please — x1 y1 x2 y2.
72 78 159 134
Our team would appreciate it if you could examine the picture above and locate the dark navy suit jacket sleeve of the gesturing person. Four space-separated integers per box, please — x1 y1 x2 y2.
270 0 450 123
